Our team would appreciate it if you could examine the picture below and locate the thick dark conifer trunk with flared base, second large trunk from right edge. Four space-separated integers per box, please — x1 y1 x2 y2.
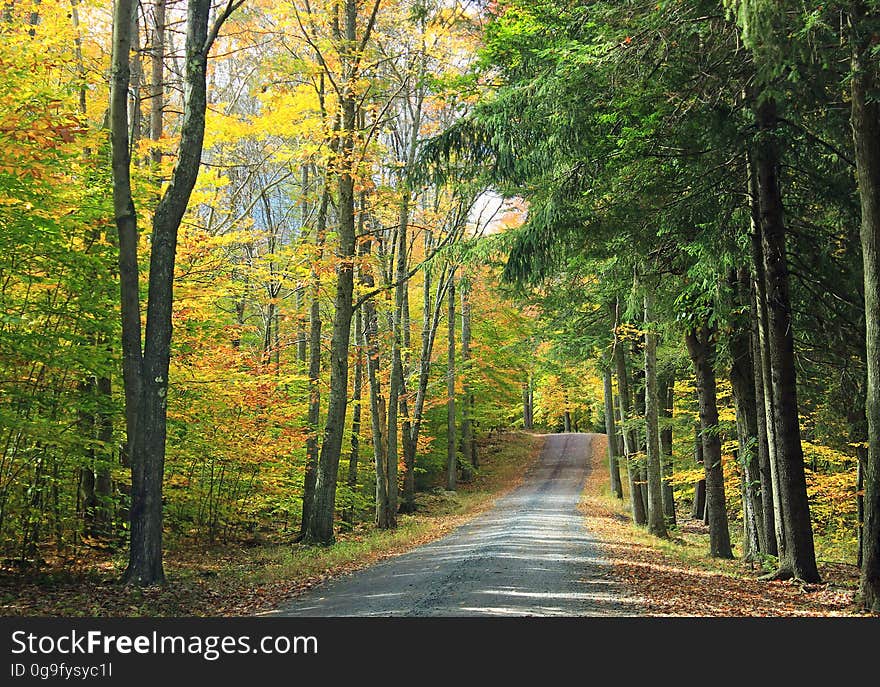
755 98 820 582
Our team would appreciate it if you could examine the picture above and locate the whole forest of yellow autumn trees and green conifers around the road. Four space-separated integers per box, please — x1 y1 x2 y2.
0 0 880 614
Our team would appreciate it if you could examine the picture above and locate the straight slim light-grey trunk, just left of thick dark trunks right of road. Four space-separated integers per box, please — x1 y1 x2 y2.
644 287 669 538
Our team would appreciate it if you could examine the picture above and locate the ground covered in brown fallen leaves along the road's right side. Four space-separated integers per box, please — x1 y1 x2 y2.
580 441 862 617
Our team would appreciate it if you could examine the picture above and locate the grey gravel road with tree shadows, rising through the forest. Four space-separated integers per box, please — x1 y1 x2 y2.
272 434 638 617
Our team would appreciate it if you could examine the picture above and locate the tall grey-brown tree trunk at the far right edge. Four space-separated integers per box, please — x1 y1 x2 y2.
850 0 880 613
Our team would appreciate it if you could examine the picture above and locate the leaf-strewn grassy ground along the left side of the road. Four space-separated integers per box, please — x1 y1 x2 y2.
0 432 543 617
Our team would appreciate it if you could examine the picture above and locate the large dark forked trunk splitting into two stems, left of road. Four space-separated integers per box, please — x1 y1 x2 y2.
110 0 227 585
